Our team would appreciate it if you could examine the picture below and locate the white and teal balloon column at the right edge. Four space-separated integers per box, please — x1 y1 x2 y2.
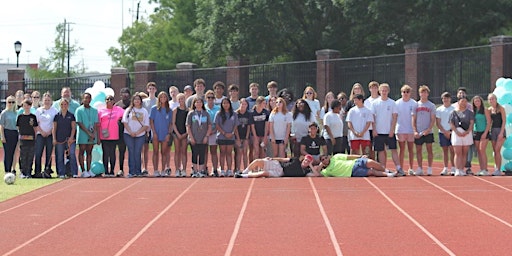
493 77 512 172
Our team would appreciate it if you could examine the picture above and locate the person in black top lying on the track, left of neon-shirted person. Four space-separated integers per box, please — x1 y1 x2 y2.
235 155 313 178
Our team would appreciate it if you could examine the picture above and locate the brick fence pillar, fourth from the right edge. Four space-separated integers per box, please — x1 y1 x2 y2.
226 56 250 97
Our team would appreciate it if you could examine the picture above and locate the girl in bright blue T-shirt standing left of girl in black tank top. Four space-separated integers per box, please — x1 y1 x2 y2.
149 92 174 177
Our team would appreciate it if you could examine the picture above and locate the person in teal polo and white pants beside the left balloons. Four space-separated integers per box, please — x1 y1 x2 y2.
75 92 98 178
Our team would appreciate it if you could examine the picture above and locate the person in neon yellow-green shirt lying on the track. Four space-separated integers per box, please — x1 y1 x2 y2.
311 154 396 177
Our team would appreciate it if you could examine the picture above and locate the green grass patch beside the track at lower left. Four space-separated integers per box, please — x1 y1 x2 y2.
0 175 60 202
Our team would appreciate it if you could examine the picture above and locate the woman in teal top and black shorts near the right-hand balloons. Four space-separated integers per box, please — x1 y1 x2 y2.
471 95 491 176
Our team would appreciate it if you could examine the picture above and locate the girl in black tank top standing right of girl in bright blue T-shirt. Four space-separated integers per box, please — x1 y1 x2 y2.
172 93 188 177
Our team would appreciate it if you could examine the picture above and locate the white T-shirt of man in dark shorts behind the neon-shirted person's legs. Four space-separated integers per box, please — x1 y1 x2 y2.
372 98 398 134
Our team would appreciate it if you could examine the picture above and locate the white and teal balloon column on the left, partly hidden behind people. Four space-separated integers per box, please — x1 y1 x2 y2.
85 81 115 175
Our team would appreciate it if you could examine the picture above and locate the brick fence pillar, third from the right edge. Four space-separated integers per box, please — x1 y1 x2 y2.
315 49 341 104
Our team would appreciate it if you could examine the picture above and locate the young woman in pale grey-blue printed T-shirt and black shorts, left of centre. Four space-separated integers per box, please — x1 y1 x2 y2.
186 97 212 178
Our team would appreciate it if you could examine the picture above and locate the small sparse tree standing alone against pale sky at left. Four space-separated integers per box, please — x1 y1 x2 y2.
28 23 85 79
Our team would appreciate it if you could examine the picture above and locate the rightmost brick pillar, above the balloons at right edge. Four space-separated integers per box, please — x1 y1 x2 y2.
490 36 512 92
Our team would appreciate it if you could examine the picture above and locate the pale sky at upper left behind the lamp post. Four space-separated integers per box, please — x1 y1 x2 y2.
0 0 156 73
